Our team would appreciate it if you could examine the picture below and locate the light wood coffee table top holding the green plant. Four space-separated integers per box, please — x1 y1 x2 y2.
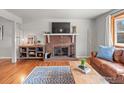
69 61 108 84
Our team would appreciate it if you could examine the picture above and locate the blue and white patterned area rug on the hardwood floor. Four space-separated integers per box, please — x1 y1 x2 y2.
23 66 75 84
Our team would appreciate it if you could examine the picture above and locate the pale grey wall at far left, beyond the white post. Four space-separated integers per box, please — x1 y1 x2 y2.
0 17 14 57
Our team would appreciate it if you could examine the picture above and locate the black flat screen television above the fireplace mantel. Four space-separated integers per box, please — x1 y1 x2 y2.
52 22 70 33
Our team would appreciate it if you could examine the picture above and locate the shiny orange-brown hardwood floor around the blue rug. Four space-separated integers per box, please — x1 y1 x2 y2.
0 59 69 84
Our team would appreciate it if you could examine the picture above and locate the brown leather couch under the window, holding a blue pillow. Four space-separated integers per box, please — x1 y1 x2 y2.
90 49 124 83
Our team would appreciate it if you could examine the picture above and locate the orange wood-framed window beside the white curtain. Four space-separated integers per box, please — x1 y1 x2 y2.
111 13 124 47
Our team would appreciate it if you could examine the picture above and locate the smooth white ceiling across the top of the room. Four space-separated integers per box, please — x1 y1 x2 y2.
7 9 110 20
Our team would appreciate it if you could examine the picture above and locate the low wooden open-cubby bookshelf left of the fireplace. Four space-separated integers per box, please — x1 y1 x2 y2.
19 45 44 59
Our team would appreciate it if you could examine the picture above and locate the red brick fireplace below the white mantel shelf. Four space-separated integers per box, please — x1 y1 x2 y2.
45 35 76 57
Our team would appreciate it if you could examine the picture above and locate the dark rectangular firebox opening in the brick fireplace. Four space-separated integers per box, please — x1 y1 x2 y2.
54 47 69 56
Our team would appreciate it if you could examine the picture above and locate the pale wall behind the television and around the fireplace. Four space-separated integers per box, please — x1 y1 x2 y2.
23 19 92 57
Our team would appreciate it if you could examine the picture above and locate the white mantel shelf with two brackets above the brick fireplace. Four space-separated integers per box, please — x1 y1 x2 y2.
44 33 78 43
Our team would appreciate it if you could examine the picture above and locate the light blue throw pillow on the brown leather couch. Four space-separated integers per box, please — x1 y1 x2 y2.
97 46 115 61
